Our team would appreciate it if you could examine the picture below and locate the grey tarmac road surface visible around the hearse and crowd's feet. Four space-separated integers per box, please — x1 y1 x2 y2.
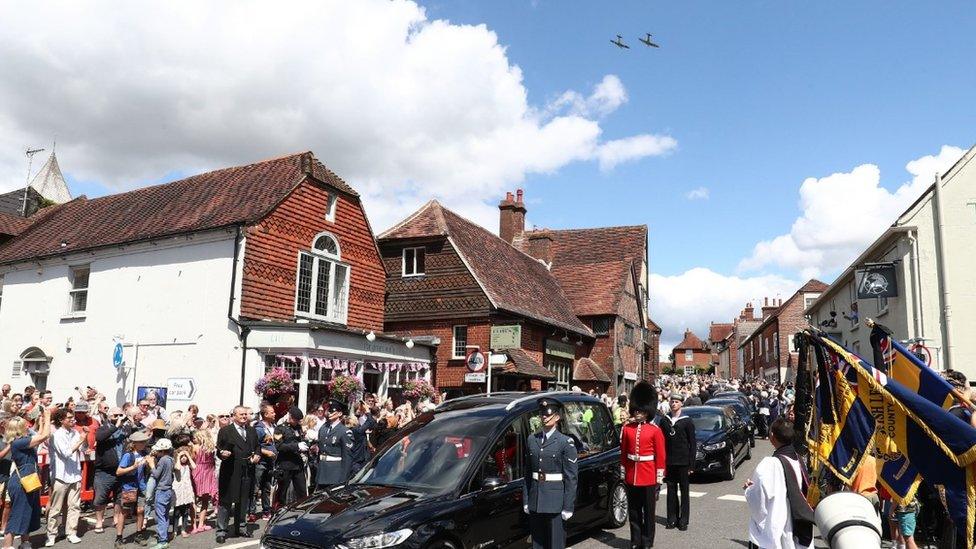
31 440 827 549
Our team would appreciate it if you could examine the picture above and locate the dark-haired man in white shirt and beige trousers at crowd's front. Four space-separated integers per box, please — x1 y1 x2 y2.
44 408 85 547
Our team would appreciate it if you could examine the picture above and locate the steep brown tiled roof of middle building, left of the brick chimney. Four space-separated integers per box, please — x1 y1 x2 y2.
379 200 592 335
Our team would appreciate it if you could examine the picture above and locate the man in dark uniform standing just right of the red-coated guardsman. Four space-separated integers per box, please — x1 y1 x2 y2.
661 391 698 531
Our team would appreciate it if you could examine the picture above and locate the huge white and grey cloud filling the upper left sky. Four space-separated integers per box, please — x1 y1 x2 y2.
0 0 675 230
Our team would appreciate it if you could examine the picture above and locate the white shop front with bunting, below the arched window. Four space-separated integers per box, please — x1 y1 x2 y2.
248 322 436 410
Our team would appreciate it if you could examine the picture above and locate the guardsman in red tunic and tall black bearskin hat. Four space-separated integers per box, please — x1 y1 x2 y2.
620 381 667 549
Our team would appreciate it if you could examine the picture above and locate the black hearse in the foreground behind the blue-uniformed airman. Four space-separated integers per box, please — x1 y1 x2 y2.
261 392 627 549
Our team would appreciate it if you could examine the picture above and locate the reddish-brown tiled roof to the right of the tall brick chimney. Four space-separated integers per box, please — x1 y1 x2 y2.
512 225 647 316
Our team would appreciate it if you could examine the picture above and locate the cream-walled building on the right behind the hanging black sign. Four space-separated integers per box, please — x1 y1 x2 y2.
806 143 976 380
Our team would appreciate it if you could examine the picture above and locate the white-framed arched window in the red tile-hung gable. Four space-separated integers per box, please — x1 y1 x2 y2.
295 229 349 324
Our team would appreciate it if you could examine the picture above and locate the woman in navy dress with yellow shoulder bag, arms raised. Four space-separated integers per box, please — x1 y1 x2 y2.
3 408 51 548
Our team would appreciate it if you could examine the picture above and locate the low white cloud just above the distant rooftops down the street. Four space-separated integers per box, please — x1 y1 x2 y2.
650 267 802 360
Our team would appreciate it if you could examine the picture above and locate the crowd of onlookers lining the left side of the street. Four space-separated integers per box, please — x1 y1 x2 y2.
0 384 437 549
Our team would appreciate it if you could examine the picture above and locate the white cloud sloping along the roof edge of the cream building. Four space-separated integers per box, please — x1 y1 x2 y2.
739 145 964 278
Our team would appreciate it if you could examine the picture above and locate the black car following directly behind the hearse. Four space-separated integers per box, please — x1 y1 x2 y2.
681 406 752 480
